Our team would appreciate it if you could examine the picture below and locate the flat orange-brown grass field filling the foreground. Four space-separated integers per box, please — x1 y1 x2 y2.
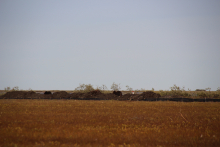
0 100 220 147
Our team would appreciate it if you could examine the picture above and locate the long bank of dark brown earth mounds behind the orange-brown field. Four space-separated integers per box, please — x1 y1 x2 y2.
0 90 220 102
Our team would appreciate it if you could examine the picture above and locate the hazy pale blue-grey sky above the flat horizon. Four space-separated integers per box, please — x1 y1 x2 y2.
0 0 220 91
